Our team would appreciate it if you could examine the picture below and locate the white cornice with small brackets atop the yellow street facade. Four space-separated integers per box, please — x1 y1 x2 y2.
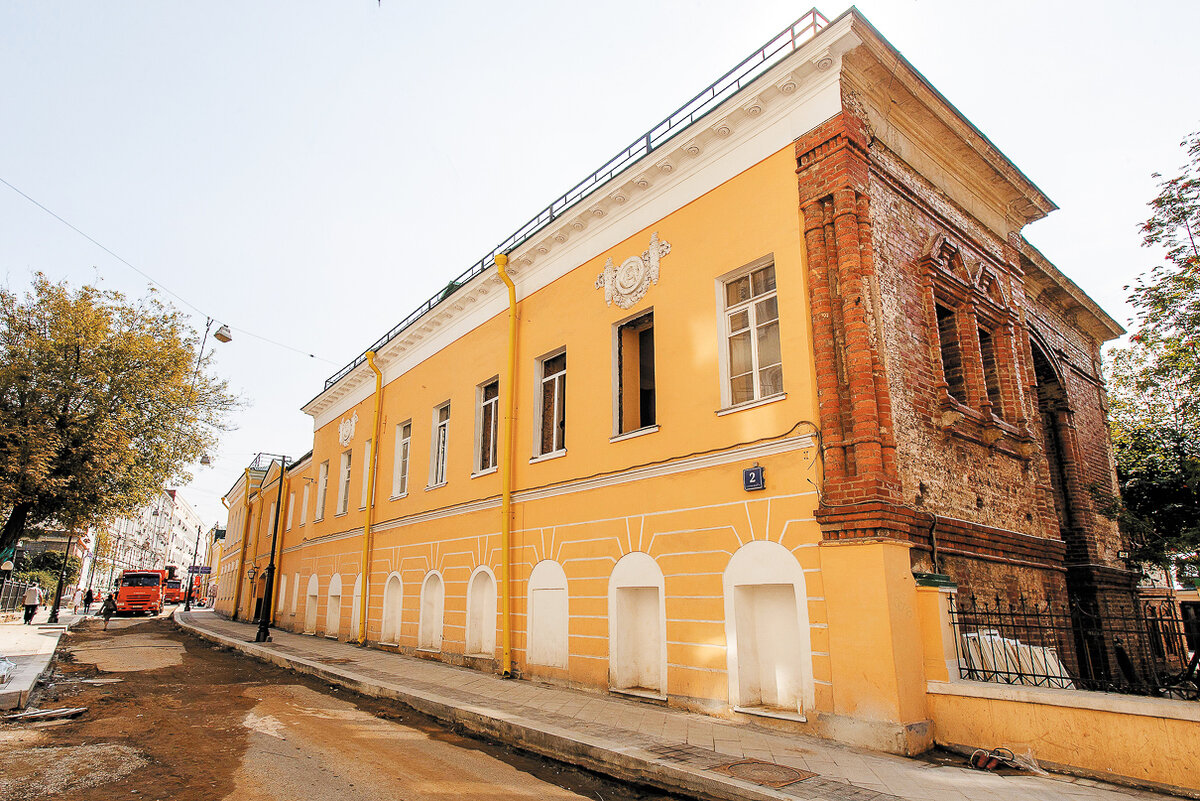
302 17 859 429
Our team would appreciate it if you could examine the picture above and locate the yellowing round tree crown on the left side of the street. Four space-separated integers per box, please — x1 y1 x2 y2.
0 273 238 550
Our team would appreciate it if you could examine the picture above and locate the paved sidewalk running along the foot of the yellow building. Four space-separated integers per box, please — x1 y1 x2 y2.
175 610 1172 801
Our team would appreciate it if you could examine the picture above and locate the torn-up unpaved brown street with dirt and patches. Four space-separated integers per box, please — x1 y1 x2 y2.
0 619 672 801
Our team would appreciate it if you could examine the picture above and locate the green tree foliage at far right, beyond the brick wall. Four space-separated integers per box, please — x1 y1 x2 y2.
1097 132 1200 578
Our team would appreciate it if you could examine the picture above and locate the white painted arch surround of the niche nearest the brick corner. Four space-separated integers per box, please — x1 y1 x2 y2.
721 540 816 715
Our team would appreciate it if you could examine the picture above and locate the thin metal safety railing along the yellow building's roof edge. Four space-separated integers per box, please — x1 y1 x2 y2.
325 8 829 390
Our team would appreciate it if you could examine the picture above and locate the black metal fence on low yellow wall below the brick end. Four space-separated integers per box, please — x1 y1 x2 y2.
950 596 1200 700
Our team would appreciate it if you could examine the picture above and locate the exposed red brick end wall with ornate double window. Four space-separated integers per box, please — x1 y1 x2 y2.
796 104 1120 601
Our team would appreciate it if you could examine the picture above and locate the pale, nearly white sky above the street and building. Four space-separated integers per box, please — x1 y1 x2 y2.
0 0 1200 525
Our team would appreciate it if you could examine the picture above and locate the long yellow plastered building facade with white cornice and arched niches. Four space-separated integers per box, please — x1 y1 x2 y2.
216 12 1132 752
